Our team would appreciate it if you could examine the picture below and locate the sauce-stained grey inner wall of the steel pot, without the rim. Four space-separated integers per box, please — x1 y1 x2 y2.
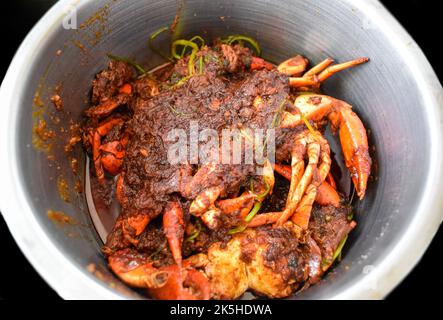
15 0 429 298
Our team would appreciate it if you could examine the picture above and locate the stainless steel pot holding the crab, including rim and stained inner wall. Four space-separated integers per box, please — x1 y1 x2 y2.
0 0 443 299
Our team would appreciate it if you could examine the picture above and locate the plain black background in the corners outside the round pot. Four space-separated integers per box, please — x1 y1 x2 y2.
0 0 443 300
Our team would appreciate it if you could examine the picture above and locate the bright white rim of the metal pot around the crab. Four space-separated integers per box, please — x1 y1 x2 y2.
0 0 443 299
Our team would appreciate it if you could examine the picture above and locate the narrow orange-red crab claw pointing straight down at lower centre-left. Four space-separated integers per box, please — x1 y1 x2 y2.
163 201 185 267
